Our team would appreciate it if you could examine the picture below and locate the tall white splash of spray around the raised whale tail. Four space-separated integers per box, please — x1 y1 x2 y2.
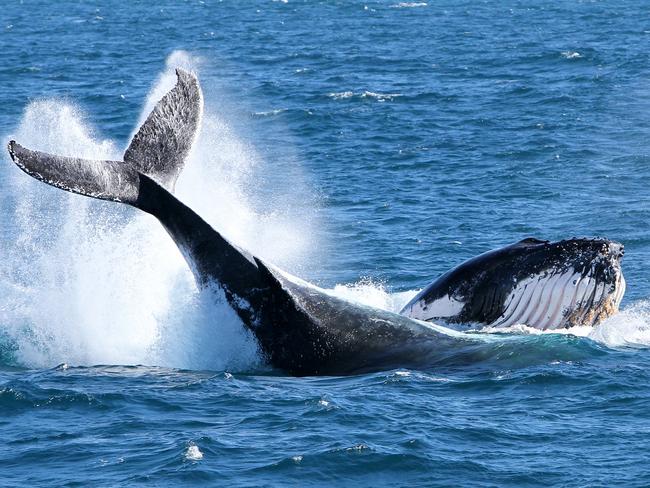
0 51 310 370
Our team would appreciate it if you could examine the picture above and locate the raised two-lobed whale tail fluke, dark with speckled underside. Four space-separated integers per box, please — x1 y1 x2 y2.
8 69 203 207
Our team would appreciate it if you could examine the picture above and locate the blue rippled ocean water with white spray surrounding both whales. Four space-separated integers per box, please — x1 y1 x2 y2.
0 0 650 486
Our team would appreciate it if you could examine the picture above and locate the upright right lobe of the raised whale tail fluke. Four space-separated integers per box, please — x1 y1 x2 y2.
124 68 203 192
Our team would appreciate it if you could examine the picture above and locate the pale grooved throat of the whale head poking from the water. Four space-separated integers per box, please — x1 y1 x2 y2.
489 241 626 330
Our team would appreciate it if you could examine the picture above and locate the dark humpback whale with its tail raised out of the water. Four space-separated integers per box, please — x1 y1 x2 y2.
8 69 473 375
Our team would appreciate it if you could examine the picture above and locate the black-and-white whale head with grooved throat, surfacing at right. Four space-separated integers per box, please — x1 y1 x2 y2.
401 238 625 329
